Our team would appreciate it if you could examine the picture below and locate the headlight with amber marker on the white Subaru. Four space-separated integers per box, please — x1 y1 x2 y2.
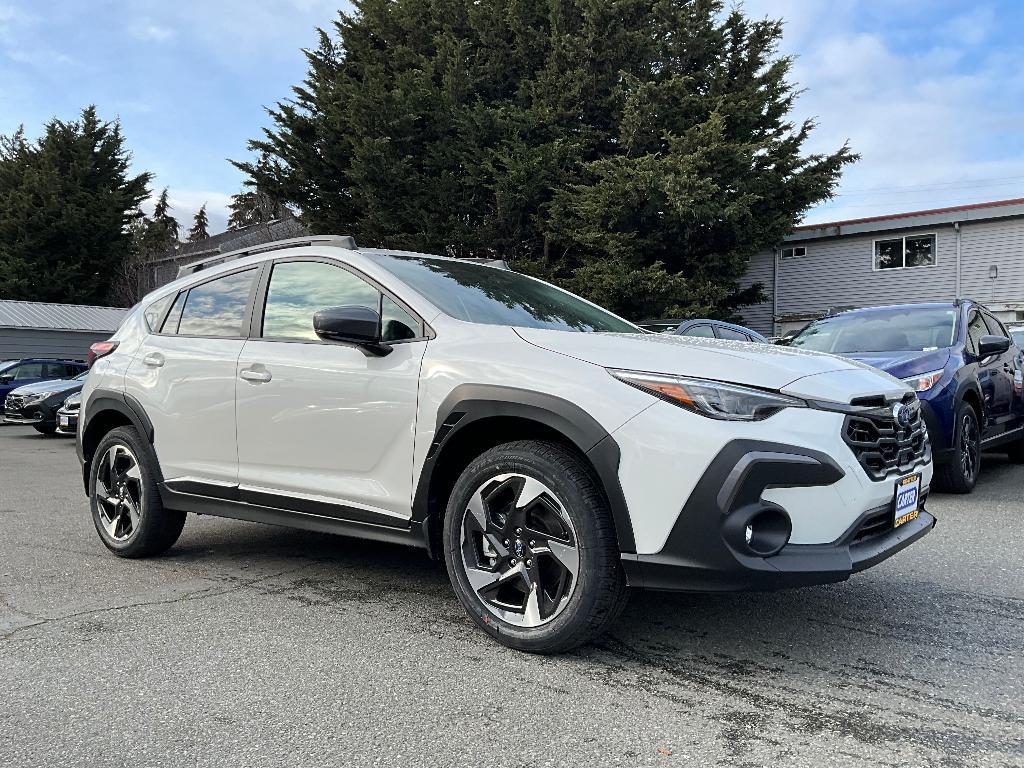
609 370 807 421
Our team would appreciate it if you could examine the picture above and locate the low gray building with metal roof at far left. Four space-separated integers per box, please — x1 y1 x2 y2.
0 300 128 360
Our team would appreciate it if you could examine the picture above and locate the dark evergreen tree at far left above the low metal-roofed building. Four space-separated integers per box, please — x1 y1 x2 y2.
0 106 151 304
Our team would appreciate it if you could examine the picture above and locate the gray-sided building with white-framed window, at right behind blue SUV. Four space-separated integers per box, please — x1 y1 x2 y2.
741 199 1024 336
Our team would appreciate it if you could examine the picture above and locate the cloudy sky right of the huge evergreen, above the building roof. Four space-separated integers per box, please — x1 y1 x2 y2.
745 0 1024 223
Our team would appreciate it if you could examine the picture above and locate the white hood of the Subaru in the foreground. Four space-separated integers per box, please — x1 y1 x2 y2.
516 329 907 401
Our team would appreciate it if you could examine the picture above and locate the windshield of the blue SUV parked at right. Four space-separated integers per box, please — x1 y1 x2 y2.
790 307 956 354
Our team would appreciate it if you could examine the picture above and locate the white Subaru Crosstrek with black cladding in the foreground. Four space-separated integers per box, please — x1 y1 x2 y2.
78 237 935 652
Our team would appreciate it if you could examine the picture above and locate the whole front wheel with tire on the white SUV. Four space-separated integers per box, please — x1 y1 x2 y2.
444 440 628 653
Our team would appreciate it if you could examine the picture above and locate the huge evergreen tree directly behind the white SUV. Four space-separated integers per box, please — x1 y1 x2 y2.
237 0 855 317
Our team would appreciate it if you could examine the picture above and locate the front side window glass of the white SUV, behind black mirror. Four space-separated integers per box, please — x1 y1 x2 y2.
263 261 380 340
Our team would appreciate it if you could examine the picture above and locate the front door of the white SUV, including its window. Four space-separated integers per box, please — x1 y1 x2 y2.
234 258 427 524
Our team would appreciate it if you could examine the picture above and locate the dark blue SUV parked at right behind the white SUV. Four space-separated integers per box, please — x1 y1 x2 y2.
790 299 1024 494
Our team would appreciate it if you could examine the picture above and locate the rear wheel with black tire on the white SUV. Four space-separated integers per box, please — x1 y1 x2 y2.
89 427 185 558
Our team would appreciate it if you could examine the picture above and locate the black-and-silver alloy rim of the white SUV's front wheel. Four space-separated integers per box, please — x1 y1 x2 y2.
461 473 580 628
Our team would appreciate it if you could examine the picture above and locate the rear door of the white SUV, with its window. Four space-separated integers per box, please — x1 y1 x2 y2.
125 266 260 493
